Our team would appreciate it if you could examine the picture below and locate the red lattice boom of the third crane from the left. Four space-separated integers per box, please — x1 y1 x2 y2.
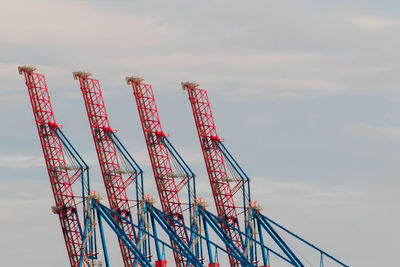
126 77 188 267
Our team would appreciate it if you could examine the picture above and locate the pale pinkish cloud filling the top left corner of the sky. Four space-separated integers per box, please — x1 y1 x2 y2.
0 0 182 49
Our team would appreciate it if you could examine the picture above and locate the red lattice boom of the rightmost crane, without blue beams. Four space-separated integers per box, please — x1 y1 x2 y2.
182 82 242 266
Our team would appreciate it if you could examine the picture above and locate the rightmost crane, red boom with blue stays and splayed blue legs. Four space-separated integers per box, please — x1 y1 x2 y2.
182 82 347 267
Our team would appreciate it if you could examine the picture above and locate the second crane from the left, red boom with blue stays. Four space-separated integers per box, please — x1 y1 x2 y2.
73 72 143 267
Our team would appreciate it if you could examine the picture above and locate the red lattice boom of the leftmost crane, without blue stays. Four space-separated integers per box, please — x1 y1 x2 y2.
18 66 83 267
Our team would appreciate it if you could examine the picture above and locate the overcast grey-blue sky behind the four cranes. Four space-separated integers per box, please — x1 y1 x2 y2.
0 0 400 267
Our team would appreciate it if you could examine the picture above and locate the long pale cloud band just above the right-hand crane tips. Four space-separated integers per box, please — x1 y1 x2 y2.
107 51 354 99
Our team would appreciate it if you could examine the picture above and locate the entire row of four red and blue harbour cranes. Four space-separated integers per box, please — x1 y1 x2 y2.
18 70 348 267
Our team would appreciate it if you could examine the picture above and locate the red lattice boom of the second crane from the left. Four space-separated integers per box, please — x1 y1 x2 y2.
73 72 135 267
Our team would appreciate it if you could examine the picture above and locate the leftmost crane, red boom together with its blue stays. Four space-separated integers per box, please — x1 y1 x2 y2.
18 66 101 267
